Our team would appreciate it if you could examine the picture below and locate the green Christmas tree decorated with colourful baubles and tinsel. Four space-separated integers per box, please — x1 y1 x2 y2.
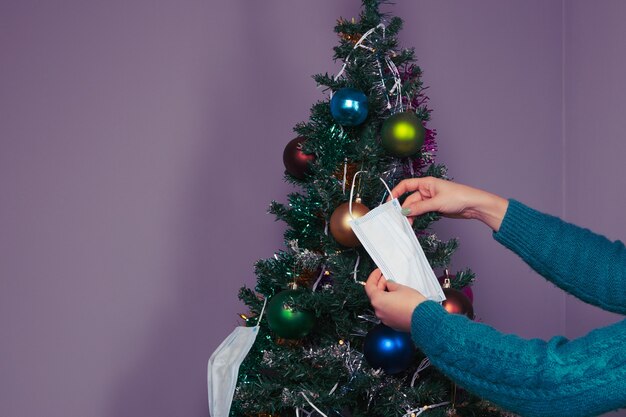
230 0 503 417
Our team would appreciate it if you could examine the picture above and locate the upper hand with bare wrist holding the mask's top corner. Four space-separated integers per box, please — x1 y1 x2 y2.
391 177 509 232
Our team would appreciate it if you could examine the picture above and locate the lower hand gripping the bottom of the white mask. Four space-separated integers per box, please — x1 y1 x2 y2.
365 269 426 332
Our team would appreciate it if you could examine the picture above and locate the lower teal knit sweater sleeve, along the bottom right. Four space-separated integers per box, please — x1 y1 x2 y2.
411 301 626 417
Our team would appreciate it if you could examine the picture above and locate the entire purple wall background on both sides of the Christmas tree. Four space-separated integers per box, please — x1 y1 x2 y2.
0 0 626 417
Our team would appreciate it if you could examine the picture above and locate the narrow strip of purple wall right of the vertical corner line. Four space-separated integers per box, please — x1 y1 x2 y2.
564 0 626 340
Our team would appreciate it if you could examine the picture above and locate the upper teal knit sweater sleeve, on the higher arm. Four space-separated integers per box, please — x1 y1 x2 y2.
493 200 626 314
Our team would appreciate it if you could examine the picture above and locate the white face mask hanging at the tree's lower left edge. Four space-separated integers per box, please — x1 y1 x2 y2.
207 300 267 417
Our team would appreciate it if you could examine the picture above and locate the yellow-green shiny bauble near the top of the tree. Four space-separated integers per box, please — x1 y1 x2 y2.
381 111 426 158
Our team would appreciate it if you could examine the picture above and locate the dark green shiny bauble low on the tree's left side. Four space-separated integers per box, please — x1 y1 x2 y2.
267 290 315 339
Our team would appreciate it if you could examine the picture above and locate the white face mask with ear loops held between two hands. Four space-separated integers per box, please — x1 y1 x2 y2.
349 172 446 302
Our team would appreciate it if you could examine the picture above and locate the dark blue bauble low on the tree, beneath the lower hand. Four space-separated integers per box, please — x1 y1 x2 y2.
363 323 415 374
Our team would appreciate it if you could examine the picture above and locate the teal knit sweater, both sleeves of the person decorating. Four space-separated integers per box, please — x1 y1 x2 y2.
411 200 626 417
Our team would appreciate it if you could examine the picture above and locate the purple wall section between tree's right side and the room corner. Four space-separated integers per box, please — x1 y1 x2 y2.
398 0 564 338
